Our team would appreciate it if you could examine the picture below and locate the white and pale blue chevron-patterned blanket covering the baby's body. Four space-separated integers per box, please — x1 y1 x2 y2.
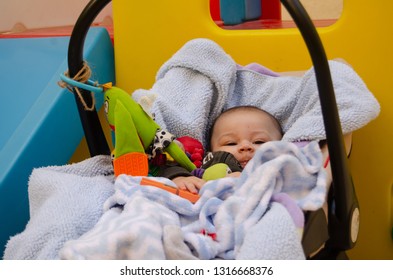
60 141 326 259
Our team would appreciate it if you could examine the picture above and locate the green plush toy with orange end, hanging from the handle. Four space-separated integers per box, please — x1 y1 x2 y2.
104 85 196 176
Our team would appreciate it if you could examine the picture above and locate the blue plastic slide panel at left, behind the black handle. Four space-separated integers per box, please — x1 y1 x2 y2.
0 28 115 255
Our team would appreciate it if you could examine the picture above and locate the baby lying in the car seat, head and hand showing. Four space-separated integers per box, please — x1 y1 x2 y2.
159 106 282 193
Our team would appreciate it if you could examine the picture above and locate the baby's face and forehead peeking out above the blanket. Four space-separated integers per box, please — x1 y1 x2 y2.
211 110 282 168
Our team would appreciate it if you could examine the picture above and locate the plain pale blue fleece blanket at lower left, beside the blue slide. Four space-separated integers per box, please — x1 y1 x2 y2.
3 156 114 260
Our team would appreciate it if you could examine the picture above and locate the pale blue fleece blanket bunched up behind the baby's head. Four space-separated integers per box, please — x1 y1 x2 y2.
133 39 380 146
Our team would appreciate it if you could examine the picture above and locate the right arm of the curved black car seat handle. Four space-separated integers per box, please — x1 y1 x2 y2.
281 0 359 250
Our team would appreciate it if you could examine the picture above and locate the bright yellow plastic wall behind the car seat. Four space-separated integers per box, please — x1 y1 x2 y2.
113 0 393 259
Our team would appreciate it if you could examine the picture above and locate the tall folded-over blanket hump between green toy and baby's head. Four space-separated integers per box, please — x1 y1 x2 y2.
133 39 237 147
